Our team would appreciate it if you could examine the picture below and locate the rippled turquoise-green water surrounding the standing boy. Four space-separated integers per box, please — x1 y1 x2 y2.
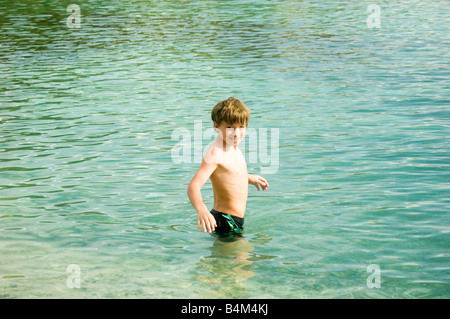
0 0 450 298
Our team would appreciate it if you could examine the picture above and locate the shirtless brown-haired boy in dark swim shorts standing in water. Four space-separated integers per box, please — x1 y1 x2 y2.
187 97 269 233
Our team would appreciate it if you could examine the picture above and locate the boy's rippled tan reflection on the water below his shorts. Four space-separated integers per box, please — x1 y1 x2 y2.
195 234 254 298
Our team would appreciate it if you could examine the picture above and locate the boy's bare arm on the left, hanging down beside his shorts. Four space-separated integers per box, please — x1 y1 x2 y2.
187 159 217 233
